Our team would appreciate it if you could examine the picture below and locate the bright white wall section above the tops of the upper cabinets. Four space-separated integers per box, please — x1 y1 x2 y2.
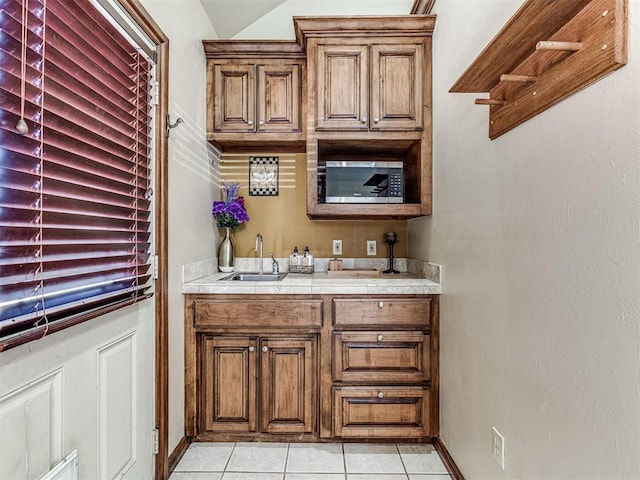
233 0 413 40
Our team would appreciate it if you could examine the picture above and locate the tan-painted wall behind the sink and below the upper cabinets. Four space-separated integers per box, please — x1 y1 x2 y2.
221 154 407 258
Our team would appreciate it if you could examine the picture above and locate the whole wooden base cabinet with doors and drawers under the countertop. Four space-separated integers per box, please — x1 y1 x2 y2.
185 294 439 441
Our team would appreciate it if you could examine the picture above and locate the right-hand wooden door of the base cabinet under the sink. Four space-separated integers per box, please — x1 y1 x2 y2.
260 337 317 433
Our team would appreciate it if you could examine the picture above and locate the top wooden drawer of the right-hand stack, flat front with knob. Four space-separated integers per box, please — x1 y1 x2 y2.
333 297 431 328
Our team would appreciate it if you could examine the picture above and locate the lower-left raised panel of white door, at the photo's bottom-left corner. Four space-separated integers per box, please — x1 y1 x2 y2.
0 368 63 480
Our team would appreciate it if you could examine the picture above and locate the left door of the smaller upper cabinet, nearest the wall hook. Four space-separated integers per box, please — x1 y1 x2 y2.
212 65 255 133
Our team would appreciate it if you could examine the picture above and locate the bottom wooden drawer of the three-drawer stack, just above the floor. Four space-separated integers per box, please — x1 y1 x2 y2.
333 387 431 438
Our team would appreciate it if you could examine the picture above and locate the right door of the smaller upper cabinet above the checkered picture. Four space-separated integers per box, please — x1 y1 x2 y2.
256 64 301 132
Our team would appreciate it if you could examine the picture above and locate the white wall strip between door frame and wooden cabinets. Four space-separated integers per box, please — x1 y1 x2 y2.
142 0 220 453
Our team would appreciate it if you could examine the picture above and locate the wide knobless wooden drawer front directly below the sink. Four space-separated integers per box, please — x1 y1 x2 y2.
193 298 322 328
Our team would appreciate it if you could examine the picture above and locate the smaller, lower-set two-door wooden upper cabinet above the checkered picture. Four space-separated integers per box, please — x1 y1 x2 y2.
203 40 305 152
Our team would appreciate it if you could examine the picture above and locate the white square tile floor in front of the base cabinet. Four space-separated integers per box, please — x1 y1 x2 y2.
170 442 451 480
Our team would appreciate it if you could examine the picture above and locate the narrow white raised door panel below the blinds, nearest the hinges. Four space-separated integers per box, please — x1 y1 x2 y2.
98 332 138 480
